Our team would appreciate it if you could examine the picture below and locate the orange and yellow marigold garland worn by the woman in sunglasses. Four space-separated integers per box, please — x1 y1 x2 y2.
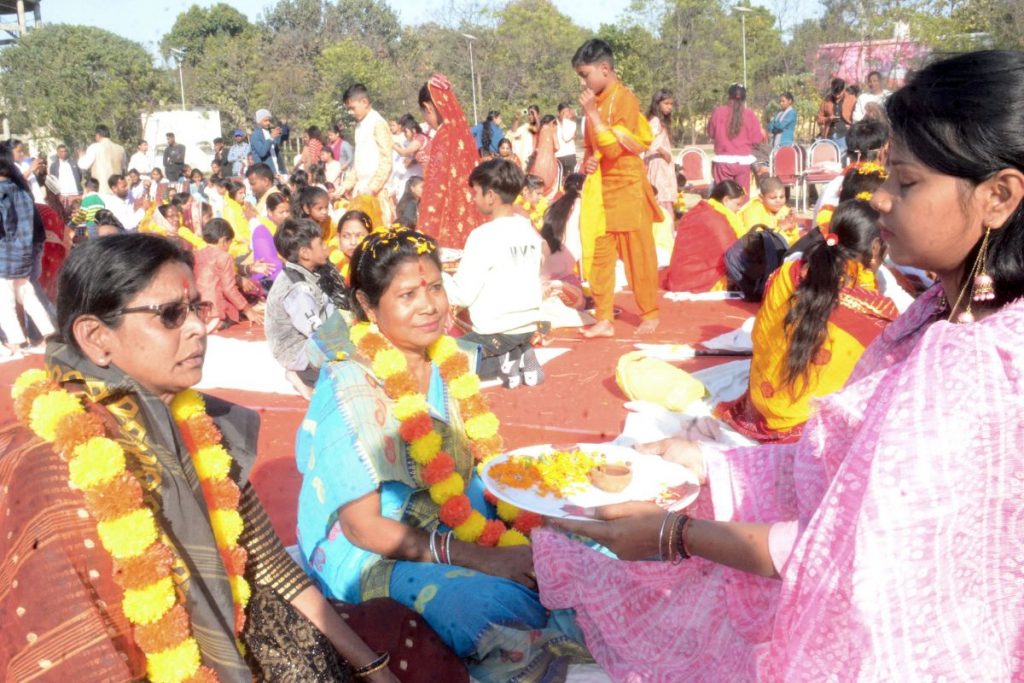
11 370 250 683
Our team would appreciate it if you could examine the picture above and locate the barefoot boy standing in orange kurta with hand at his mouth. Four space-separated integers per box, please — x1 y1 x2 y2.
572 38 662 337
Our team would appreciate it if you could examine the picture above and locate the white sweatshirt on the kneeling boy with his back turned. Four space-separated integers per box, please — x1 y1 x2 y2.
444 215 543 335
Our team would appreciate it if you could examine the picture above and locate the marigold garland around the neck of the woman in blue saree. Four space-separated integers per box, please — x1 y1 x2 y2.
349 323 536 547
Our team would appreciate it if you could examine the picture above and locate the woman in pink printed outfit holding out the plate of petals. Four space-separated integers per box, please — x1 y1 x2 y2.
534 51 1024 682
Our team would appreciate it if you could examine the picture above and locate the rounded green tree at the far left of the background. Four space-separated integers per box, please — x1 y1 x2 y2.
0 24 163 143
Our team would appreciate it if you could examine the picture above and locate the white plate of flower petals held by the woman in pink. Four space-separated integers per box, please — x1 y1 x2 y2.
480 443 700 519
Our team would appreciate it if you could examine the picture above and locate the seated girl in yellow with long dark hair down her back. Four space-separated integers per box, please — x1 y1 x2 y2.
715 200 899 442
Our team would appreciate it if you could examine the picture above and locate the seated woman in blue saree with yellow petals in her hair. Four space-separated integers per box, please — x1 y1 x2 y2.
296 229 589 681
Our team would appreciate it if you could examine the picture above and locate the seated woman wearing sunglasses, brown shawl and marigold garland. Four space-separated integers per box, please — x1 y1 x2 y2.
0 233 466 682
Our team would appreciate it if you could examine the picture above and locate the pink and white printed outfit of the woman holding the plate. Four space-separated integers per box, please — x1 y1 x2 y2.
534 289 1024 682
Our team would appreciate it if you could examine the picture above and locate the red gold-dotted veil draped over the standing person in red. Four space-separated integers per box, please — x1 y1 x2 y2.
416 74 483 249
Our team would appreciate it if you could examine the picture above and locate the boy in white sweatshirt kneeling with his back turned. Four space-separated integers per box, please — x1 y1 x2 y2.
444 159 543 387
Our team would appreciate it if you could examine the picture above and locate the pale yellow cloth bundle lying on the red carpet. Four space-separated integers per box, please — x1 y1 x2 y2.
615 351 708 412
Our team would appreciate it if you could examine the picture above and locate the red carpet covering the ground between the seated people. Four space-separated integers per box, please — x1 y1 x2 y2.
0 293 757 544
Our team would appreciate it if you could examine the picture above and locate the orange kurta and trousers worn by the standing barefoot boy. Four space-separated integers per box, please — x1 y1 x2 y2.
584 81 662 321
